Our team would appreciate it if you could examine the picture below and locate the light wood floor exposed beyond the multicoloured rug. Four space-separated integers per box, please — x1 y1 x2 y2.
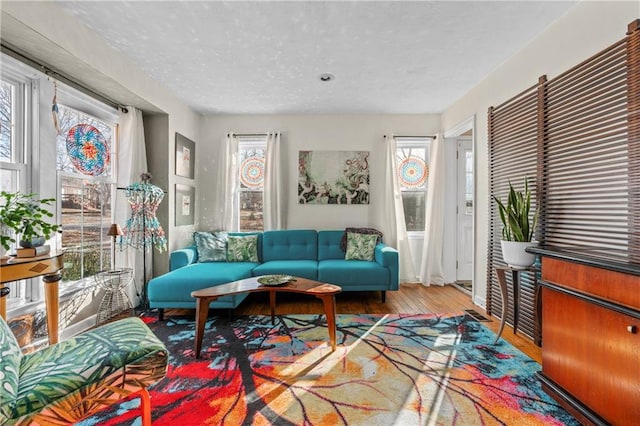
165 284 542 363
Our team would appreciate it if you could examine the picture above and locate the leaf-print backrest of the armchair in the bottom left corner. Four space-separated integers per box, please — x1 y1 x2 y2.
0 317 22 416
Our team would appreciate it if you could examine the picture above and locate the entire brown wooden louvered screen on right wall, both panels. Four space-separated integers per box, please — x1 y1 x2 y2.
487 20 640 342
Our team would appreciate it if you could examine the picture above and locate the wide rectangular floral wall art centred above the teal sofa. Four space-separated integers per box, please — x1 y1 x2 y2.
298 151 369 204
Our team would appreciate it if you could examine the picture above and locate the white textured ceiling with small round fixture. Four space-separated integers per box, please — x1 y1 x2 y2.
56 0 573 114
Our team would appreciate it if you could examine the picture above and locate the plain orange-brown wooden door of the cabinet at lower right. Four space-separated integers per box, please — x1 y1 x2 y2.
542 287 640 424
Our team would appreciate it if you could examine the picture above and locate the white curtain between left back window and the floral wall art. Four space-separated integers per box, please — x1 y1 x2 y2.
263 132 285 230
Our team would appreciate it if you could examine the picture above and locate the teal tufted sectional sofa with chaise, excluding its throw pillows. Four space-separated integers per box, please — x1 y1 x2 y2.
148 229 399 318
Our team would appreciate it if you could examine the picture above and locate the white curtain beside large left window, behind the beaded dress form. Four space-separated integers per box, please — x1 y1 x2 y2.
113 106 152 306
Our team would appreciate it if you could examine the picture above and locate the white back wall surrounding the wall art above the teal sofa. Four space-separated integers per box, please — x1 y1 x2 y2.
196 114 440 236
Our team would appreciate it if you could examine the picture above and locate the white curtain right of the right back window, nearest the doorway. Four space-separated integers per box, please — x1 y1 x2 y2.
420 135 445 286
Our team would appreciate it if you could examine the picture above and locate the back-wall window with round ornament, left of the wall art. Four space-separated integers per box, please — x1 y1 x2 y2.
238 136 267 231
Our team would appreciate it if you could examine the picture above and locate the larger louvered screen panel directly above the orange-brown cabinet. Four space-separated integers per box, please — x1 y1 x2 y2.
541 40 629 255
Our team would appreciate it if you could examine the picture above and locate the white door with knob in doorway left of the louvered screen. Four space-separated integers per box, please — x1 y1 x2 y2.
456 138 473 284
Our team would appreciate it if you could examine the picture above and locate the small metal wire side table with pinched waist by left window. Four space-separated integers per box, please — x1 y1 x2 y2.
95 268 133 325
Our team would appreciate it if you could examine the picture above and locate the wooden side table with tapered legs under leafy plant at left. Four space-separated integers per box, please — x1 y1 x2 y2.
0 251 63 345
